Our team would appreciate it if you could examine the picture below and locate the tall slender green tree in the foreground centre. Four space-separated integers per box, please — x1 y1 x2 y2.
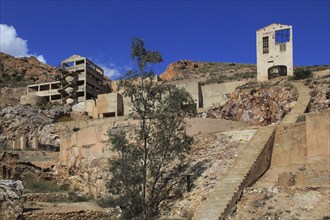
108 39 196 219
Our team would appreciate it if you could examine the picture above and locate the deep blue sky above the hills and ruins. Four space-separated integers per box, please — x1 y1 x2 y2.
0 0 330 78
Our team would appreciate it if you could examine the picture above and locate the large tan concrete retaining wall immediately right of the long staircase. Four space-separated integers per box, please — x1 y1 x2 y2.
254 116 330 187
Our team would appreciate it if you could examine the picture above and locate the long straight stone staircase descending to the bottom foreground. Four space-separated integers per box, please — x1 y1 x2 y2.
192 126 275 220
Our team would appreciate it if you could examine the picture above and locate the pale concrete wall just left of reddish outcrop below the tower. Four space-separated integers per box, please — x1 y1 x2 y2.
202 81 246 108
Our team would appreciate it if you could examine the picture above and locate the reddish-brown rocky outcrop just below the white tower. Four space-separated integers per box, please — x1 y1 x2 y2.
219 82 298 125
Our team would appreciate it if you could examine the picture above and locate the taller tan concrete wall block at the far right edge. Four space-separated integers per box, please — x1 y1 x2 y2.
306 110 330 163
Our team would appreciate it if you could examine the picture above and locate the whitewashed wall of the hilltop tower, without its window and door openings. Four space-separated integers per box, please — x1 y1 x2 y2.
256 23 293 81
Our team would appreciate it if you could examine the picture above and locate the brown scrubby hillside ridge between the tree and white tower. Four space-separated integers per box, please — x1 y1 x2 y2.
160 60 257 84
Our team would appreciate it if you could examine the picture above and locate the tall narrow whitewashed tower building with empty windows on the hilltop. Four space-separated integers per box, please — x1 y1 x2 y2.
256 23 293 81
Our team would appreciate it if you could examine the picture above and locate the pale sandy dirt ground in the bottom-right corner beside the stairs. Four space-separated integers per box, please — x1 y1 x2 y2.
228 187 330 220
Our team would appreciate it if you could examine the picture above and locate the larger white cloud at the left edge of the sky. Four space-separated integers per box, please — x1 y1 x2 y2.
0 24 46 63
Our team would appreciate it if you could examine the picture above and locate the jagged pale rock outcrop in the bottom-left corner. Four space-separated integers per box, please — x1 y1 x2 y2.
0 180 23 220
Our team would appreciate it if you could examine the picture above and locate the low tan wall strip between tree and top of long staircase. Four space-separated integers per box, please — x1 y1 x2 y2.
185 118 250 136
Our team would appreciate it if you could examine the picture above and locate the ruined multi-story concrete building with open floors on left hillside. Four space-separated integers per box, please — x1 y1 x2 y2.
27 55 105 104
